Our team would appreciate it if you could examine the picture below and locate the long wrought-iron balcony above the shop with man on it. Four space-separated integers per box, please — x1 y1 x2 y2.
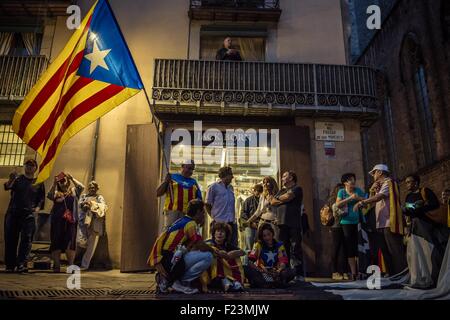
152 59 382 121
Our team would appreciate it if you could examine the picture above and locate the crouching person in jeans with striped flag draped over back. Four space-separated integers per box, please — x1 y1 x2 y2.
148 199 226 294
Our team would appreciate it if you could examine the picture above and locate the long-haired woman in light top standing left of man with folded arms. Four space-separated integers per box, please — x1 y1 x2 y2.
247 176 279 239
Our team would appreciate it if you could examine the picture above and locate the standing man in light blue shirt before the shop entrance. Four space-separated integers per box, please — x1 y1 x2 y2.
205 167 238 247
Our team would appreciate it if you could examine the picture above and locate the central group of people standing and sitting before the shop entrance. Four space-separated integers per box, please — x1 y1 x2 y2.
152 160 303 294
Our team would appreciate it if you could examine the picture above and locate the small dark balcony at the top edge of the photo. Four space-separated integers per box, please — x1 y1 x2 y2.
189 0 281 22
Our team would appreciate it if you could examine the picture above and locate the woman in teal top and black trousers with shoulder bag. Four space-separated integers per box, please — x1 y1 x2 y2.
336 173 364 280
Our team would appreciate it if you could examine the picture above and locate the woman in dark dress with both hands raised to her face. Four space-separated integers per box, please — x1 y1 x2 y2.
47 172 84 273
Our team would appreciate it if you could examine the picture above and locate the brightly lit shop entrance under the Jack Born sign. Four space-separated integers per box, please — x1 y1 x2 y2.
170 124 280 242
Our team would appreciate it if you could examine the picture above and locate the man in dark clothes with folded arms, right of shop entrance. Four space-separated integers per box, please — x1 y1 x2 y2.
270 171 303 276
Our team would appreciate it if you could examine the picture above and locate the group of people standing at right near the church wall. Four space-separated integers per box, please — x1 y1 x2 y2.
321 164 450 287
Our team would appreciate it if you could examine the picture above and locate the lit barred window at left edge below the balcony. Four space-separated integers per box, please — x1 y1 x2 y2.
0 124 27 166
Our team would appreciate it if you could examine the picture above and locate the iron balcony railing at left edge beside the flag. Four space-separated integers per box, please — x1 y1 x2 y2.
0 56 48 104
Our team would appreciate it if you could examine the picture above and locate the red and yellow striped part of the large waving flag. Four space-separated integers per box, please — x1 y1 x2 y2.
13 3 140 183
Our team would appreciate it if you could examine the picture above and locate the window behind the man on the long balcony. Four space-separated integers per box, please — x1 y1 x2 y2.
200 35 265 61
